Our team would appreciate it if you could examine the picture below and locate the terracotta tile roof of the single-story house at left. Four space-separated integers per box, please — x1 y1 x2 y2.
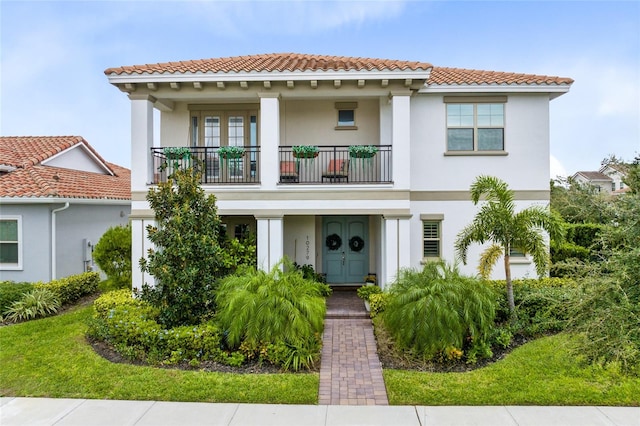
0 136 131 200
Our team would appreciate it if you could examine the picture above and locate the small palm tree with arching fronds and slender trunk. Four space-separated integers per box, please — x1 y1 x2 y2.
455 176 560 316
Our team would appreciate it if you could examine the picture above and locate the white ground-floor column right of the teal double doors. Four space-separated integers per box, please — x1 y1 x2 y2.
380 214 411 289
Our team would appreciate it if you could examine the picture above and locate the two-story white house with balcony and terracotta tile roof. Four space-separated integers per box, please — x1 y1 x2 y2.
105 53 573 287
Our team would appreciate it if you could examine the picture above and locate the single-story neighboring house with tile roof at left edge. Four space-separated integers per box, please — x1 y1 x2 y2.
0 136 131 282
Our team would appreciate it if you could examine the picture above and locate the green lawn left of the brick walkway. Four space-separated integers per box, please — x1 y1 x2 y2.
0 307 319 404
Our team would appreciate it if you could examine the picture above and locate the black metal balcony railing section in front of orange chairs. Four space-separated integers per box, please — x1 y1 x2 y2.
280 145 392 184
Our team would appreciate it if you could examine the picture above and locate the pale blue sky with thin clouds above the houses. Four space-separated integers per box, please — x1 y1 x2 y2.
0 0 640 176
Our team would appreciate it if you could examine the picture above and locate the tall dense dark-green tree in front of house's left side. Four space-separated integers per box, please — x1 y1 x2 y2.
140 168 226 327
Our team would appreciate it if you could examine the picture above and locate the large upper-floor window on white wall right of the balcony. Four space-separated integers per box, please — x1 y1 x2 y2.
447 103 504 151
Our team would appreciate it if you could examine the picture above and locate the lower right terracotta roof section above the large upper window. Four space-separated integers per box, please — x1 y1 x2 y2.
427 67 573 85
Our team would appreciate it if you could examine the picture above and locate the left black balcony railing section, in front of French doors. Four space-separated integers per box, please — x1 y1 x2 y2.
151 146 260 184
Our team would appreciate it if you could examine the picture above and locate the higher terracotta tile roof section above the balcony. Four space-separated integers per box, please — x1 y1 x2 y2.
104 53 432 75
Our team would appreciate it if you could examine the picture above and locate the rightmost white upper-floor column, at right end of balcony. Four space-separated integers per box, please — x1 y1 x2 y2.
391 90 411 189
